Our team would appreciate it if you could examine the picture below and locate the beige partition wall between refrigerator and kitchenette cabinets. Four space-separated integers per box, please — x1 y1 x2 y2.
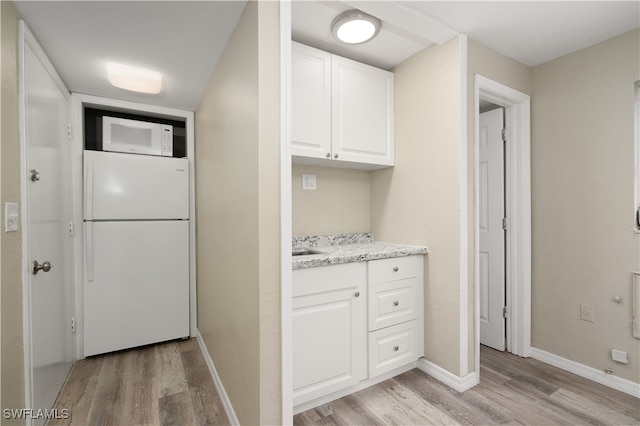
195 2 281 424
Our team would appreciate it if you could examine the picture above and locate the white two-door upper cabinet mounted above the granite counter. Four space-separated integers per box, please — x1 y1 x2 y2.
291 42 394 169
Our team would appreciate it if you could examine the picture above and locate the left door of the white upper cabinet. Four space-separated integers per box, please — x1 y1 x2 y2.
291 43 331 158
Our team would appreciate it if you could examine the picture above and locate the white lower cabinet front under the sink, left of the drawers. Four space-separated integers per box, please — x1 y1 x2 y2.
293 263 367 405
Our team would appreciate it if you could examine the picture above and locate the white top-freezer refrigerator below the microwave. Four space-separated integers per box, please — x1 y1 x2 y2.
84 151 189 356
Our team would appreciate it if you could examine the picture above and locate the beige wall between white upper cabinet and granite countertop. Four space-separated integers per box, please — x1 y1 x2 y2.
291 166 371 236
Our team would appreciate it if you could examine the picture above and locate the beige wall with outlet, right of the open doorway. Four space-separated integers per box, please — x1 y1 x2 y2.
531 30 640 383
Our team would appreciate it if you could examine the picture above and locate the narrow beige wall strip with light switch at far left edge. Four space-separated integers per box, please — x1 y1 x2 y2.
0 1 24 423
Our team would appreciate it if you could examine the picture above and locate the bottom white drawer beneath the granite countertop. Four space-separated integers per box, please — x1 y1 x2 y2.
369 320 421 378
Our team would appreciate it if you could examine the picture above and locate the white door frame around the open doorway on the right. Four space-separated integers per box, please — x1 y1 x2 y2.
474 74 531 375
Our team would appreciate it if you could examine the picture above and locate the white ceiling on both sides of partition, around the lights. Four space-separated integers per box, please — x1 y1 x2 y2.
15 0 640 111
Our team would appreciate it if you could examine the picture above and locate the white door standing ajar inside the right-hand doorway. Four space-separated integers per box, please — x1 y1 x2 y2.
478 108 506 351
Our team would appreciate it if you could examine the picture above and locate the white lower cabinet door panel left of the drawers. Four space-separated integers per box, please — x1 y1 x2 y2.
293 286 367 405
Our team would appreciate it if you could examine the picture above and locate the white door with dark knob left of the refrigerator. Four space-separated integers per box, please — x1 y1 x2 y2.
23 25 73 420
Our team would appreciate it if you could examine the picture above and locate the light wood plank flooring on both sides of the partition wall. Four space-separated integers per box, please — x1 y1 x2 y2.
48 339 640 426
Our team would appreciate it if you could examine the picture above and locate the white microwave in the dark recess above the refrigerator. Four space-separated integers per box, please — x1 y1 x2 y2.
102 116 173 157
